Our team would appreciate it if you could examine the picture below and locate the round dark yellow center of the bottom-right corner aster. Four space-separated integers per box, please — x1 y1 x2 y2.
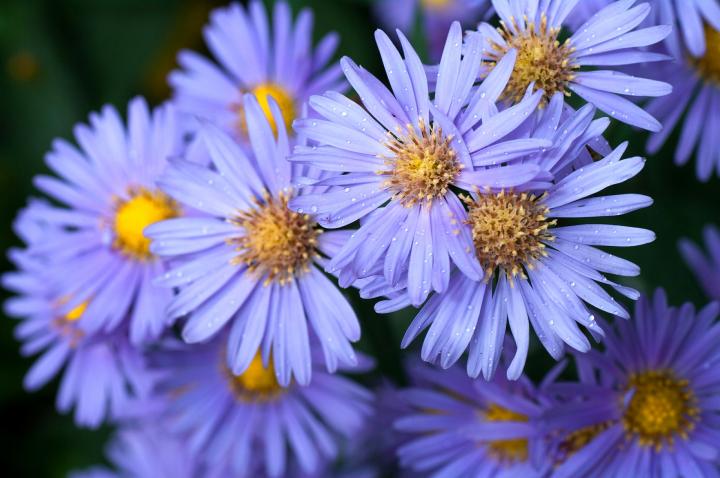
622 370 700 450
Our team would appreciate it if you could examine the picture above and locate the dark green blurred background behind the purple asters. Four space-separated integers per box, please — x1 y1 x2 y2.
0 0 720 477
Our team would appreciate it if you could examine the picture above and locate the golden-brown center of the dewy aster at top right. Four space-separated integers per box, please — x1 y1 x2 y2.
489 15 579 104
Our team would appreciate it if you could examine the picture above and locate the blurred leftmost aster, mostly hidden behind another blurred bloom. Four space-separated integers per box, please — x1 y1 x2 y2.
2 202 152 428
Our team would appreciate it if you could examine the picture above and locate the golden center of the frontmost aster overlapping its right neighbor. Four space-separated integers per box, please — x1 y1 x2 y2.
378 121 462 207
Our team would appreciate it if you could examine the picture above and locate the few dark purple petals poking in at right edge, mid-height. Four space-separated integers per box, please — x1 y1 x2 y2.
679 225 720 300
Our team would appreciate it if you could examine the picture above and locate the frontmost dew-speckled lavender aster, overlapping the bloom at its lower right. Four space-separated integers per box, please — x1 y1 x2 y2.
290 22 549 305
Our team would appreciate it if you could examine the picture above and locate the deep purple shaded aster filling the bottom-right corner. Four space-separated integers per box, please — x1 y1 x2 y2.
543 290 720 478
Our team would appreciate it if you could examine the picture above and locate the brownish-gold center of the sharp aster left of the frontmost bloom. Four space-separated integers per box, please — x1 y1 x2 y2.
229 193 321 285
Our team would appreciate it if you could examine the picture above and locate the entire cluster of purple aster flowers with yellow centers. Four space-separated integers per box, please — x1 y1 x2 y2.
3 0 720 478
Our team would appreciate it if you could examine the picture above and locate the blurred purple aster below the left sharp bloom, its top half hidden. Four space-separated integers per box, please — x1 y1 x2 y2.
146 338 372 477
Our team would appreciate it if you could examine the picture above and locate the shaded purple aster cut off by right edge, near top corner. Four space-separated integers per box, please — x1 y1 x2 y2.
642 25 720 181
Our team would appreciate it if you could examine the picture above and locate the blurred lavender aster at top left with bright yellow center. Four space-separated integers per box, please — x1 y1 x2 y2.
169 0 342 138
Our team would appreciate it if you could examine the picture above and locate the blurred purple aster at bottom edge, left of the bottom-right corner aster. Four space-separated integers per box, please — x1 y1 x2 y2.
395 360 554 478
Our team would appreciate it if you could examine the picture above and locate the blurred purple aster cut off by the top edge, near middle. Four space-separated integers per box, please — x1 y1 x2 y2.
374 0 492 61
